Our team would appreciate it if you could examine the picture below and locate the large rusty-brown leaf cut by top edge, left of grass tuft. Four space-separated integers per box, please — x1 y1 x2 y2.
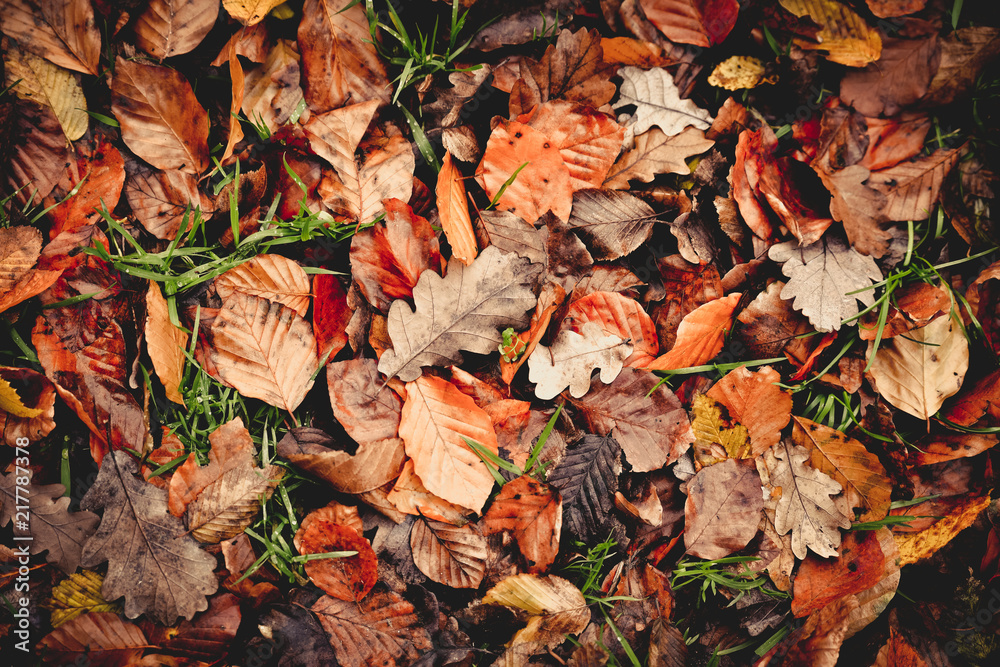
298 0 388 113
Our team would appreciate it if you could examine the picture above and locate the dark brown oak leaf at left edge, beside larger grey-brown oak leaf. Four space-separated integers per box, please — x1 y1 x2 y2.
0 466 98 574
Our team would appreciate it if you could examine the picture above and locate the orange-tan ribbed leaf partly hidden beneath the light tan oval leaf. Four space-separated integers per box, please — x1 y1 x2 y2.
215 254 312 317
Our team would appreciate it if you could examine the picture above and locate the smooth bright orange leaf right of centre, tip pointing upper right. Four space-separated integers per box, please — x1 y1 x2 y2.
647 292 742 371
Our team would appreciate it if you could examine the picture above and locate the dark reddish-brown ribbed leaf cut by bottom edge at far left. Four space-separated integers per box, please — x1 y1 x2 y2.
38 611 149 667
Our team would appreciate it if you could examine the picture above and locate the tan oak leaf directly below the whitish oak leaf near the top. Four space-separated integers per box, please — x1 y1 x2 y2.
604 127 715 188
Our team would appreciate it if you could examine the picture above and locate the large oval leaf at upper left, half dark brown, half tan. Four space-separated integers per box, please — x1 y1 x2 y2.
111 56 210 174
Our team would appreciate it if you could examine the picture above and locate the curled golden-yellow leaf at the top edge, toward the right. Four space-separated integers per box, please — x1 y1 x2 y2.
780 0 882 67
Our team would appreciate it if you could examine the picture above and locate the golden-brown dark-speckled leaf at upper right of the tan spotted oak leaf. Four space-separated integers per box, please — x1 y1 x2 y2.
792 417 892 521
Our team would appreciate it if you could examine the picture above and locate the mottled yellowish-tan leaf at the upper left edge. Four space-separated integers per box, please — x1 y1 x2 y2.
3 41 90 141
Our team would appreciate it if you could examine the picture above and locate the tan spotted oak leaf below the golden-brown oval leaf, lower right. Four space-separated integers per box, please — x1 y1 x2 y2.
757 442 851 559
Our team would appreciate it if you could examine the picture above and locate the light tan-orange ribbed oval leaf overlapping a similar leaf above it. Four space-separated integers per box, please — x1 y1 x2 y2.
211 292 319 412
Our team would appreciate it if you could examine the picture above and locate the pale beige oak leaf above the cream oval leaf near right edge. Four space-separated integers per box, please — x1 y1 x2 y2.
767 236 882 331
